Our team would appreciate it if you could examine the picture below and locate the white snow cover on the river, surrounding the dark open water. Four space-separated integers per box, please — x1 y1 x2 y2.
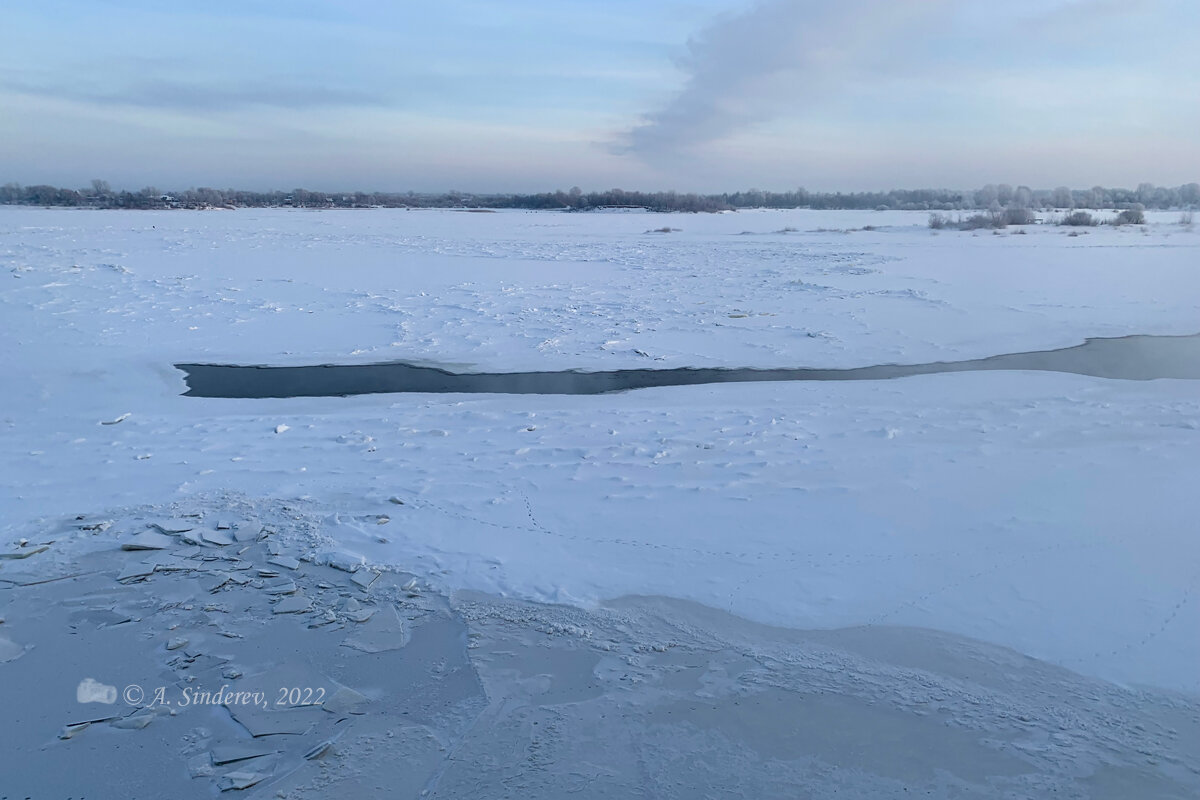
7 207 1200 693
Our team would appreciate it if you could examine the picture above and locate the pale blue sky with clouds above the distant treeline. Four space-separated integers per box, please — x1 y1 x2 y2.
0 0 1200 192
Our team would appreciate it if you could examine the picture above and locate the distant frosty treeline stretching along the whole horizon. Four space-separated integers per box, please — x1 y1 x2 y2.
0 180 1200 211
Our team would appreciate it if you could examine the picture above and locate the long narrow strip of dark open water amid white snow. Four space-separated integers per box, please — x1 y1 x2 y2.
175 333 1200 397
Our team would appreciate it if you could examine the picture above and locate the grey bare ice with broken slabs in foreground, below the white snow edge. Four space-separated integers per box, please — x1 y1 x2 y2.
0 495 1200 799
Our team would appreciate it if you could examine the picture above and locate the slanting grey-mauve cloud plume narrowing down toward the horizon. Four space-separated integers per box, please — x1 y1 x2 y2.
614 0 950 156
